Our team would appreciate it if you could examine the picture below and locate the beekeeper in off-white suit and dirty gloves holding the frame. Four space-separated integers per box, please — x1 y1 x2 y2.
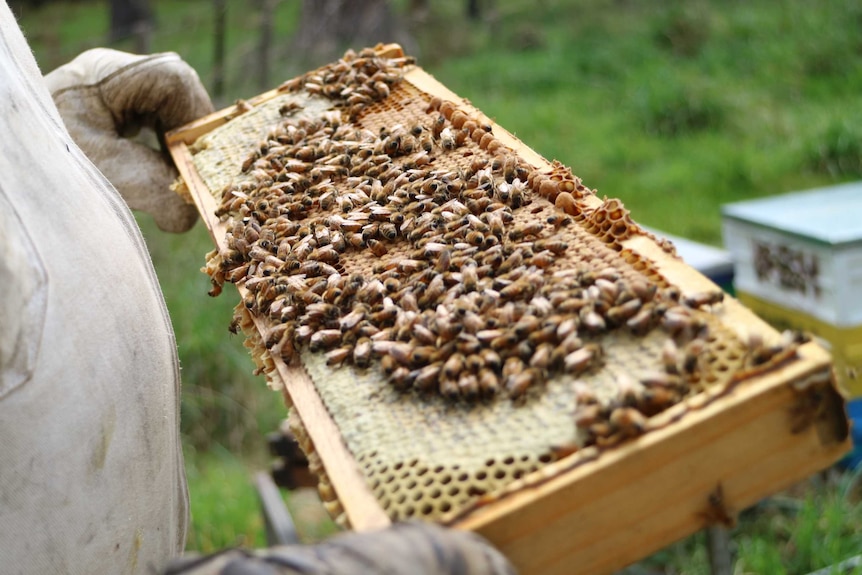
0 3 510 574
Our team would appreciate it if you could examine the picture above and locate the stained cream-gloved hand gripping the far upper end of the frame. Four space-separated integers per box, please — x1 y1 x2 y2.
45 48 213 232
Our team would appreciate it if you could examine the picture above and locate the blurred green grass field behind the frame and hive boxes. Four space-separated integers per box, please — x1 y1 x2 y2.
15 0 862 573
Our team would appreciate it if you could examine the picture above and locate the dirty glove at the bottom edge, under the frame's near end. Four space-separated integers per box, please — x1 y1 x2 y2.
163 522 515 575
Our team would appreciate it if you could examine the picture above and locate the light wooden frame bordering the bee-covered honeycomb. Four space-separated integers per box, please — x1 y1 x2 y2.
167 42 849 573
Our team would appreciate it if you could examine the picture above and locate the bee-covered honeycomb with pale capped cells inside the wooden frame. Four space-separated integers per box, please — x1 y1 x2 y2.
191 50 793 520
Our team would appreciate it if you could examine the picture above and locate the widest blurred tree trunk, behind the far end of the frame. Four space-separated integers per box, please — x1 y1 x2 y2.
292 0 415 65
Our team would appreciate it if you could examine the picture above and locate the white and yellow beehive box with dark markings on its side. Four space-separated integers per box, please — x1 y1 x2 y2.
722 182 862 395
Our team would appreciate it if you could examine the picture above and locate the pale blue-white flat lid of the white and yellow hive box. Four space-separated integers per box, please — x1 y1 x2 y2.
722 182 862 246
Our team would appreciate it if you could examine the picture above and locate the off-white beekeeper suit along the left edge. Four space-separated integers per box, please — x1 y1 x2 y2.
0 3 211 574
